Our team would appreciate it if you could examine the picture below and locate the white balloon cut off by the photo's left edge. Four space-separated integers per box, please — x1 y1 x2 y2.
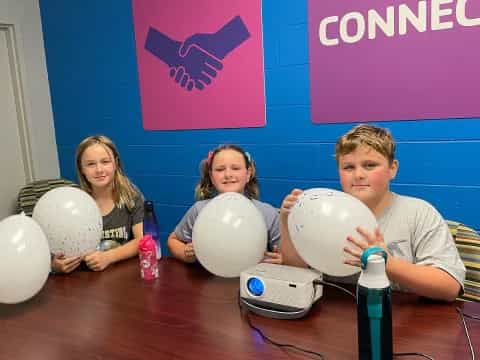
0 214 50 304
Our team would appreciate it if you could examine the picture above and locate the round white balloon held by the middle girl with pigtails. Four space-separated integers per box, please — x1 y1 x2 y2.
192 192 267 277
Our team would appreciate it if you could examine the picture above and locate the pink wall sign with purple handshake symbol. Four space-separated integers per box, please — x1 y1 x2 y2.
132 0 265 130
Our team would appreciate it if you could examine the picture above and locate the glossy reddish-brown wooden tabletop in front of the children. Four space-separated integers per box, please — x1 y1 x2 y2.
0 258 480 360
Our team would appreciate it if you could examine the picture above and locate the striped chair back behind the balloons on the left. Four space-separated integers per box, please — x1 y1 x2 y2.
17 179 79 216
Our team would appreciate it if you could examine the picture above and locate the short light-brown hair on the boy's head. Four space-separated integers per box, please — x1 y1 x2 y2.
335 124 396 165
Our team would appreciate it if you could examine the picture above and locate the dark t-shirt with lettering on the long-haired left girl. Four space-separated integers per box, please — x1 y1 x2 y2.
101 193 143 248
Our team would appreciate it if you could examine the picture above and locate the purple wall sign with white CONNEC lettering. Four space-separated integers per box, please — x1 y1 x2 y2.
308 0 480 123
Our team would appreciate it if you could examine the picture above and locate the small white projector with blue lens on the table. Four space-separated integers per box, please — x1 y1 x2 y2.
240 263 323 319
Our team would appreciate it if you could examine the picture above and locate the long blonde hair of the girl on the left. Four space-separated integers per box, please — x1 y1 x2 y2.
76 135 139 210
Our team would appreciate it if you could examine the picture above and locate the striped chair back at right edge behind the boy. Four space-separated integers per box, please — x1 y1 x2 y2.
447 220 480 301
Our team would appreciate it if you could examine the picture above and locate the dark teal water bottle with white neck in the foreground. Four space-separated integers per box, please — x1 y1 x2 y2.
357 246 393 360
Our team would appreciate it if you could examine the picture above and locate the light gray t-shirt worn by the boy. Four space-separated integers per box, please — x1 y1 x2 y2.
331 193 466 290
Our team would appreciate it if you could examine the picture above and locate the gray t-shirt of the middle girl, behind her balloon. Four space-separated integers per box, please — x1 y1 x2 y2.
174 199 280 250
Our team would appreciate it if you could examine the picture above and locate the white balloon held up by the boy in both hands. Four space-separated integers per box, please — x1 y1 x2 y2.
288 188 377 276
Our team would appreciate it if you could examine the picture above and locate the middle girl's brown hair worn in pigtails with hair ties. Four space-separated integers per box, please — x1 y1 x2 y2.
195 144 260 200
